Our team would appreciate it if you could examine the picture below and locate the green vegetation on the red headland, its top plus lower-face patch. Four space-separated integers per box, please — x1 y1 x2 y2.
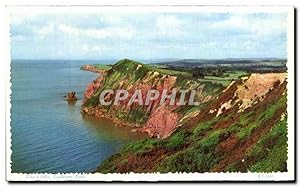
83 59 226 126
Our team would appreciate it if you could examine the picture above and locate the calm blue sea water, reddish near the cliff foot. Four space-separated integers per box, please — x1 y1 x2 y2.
11 60 142 173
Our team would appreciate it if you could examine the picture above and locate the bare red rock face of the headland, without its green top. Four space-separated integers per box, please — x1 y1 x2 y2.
83 71 184 138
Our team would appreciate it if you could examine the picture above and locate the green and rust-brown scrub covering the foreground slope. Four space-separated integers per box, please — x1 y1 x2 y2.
97 85 287 173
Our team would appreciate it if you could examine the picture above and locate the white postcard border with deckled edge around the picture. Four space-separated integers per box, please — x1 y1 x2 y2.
2 5 295 181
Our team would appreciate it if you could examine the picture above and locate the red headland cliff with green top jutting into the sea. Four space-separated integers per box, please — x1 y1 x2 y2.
82 60 222 139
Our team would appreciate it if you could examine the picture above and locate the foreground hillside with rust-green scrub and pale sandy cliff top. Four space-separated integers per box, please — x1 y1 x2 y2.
97 73 288 173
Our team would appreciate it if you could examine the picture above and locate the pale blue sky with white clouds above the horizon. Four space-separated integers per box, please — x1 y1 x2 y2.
10 12 287 59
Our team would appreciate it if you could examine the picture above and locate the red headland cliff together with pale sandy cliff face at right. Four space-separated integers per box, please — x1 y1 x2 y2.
82 60 286 142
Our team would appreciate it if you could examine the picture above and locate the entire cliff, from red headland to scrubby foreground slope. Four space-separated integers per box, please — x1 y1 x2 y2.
82 60 288 173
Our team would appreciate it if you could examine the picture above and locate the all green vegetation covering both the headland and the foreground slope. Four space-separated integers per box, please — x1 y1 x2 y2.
81 59 287 173
